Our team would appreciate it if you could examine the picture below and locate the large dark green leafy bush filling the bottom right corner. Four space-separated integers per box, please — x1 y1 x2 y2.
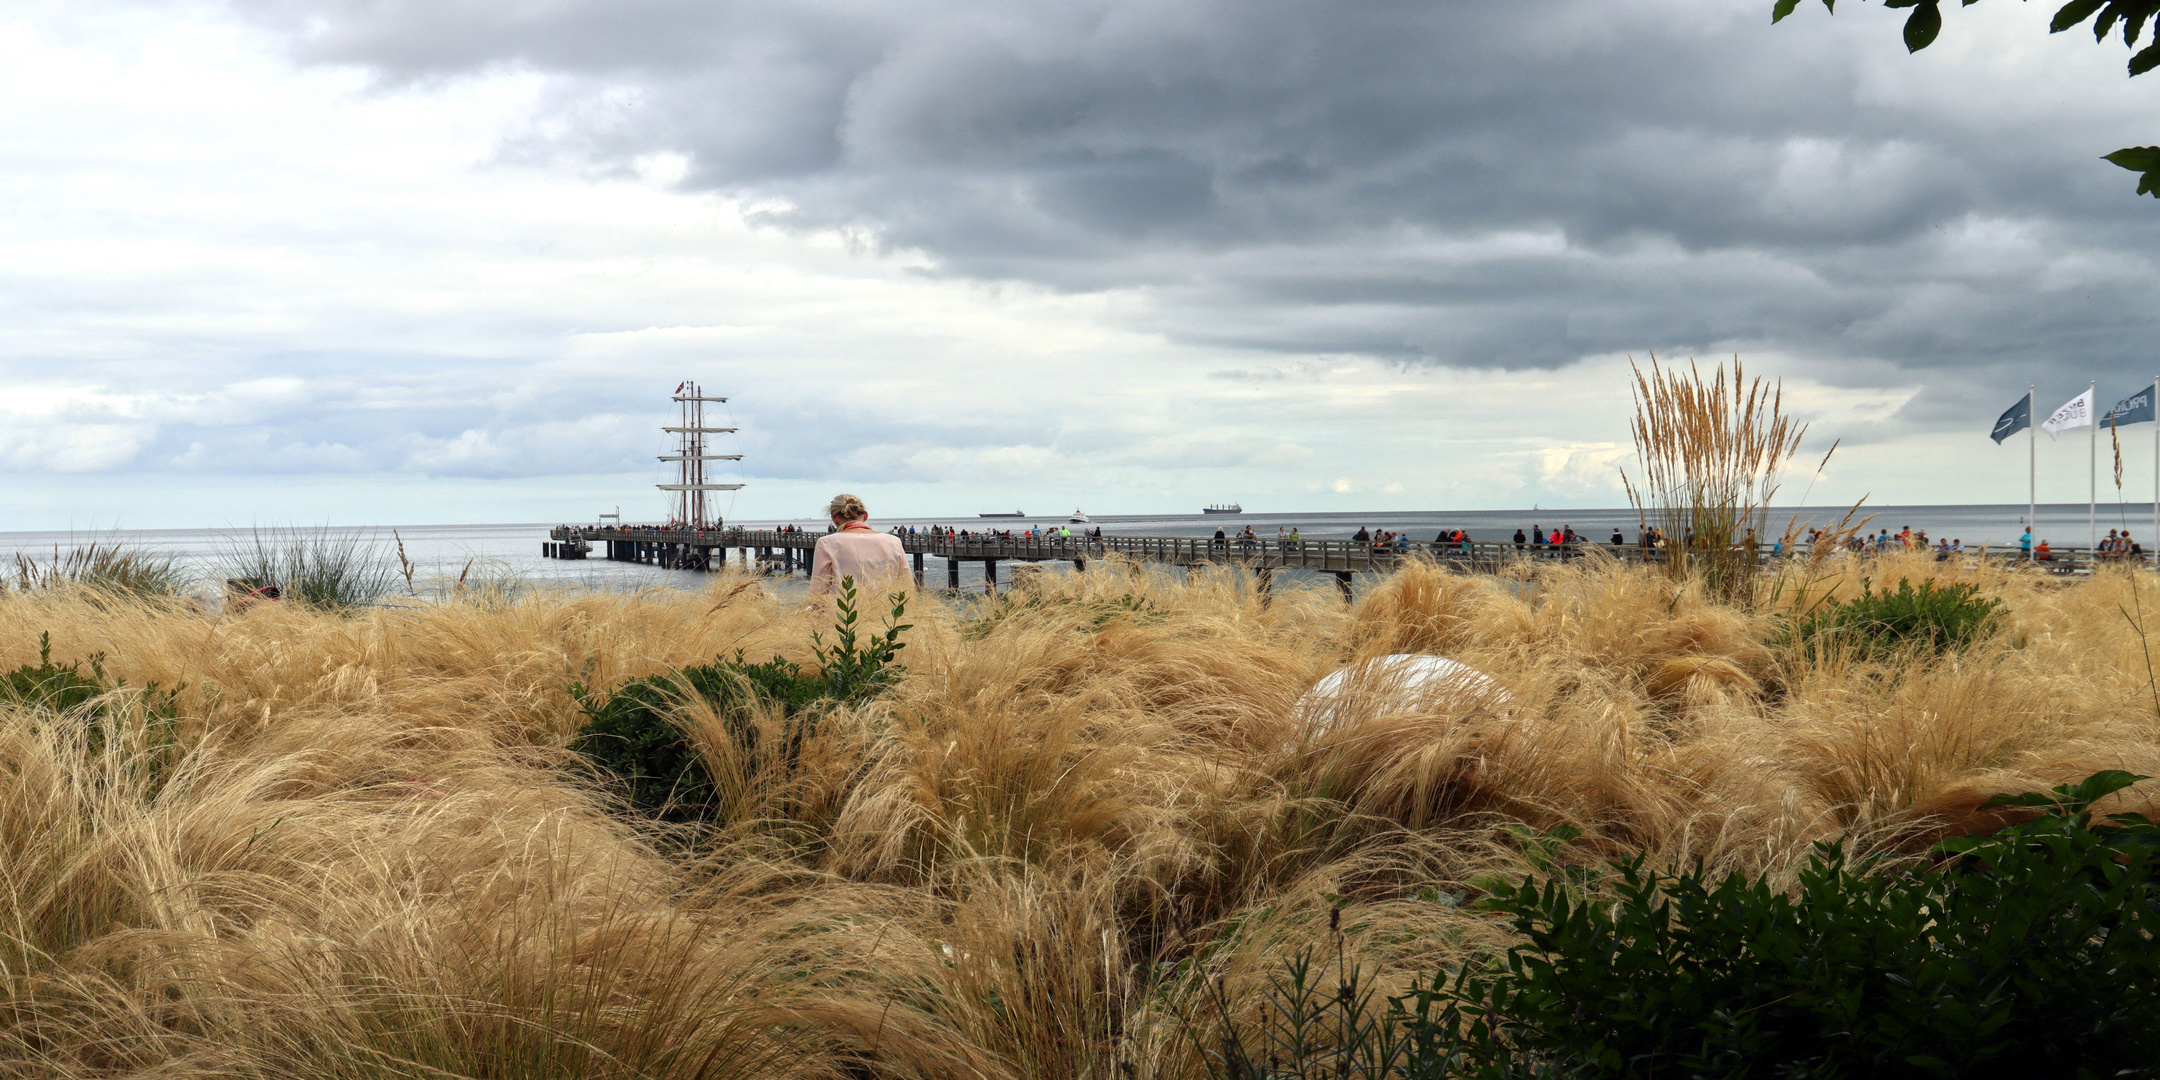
1212 771 2160 1080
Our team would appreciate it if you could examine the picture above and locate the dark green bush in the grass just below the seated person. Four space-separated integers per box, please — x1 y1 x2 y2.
570 579 909 823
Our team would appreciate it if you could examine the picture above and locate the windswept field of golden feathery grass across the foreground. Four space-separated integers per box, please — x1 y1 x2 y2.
0 557 2160 1080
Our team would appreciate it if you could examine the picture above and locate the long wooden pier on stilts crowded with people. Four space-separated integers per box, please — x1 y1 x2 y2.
540 525 2091 594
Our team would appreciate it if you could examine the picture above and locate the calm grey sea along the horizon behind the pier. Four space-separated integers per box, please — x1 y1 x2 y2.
0 503 2154 588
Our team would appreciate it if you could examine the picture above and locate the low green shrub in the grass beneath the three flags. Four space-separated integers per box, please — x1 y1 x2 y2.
1786 579 2002 659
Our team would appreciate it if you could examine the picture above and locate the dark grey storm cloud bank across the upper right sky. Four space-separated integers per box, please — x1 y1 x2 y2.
240 0 2160 423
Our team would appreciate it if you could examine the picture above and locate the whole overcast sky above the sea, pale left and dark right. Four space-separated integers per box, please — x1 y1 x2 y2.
0 0 2160 529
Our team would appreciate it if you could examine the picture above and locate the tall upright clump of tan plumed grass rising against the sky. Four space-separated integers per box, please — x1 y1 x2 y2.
1622 354 1808 600
